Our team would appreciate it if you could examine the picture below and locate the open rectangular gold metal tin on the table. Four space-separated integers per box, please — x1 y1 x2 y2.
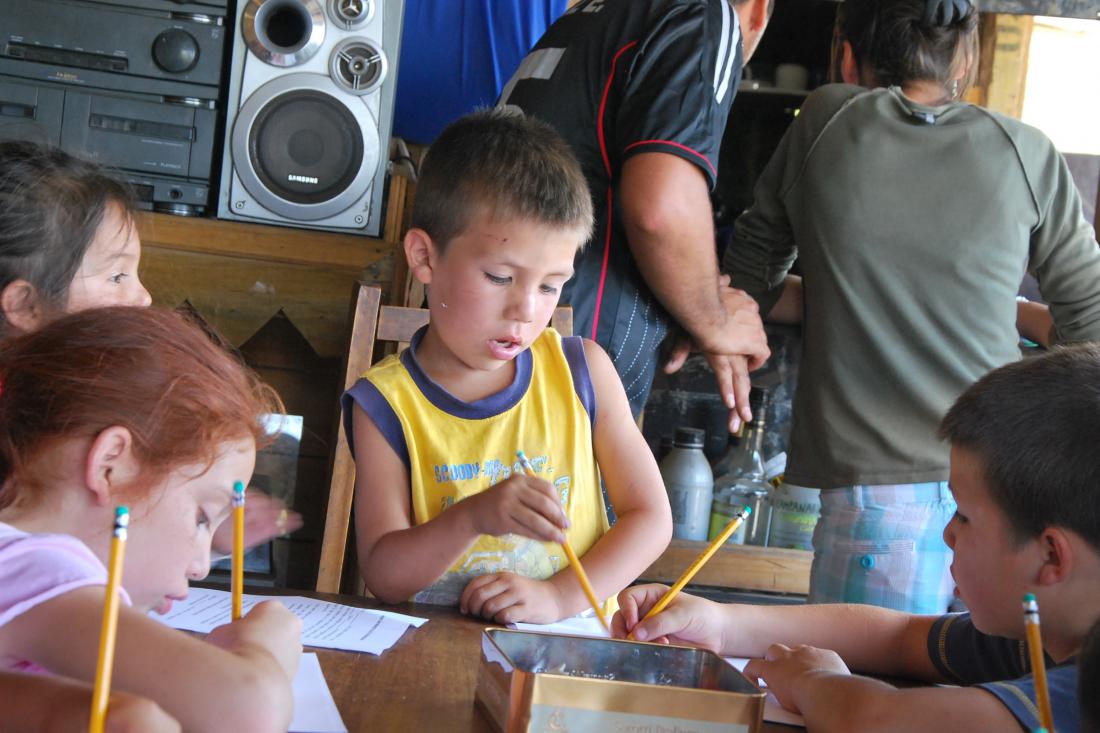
474 628 765 733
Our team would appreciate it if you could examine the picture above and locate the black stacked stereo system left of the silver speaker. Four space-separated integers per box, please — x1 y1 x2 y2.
0 0 228 215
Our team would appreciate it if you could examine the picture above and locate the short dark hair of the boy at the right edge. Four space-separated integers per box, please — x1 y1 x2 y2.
939 344 1100 550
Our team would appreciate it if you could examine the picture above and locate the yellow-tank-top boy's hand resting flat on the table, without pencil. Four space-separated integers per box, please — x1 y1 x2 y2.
459 572 563 624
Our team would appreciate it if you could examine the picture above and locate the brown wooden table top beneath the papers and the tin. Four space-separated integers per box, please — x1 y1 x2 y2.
295 592 798 733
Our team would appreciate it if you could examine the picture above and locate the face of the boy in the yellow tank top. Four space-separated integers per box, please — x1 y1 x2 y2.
430 208 583 371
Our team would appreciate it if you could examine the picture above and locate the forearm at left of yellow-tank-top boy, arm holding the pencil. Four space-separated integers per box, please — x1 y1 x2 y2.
360 502 479 603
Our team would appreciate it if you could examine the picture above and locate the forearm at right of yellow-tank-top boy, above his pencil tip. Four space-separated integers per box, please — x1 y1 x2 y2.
551 507 672 615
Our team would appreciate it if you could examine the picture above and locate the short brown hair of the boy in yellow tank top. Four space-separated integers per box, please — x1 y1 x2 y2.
411 107 592 249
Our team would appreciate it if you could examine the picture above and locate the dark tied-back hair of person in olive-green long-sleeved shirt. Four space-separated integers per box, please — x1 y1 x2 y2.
833 0 978 97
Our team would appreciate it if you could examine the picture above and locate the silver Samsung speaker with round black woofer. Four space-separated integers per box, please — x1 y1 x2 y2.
218 0 403 236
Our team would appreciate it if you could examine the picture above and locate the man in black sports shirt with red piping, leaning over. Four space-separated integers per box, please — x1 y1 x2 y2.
498 0 772 426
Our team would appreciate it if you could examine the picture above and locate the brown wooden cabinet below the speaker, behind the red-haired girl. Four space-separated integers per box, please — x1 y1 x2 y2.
138 208 405 589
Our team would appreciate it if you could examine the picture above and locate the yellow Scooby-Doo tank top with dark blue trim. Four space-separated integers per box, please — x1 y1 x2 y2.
344 328 608 604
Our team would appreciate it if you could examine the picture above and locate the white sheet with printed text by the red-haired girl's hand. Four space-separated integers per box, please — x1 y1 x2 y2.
153 588 428 654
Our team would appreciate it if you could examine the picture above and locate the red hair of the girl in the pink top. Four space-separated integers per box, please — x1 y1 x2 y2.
0 306 283 507
